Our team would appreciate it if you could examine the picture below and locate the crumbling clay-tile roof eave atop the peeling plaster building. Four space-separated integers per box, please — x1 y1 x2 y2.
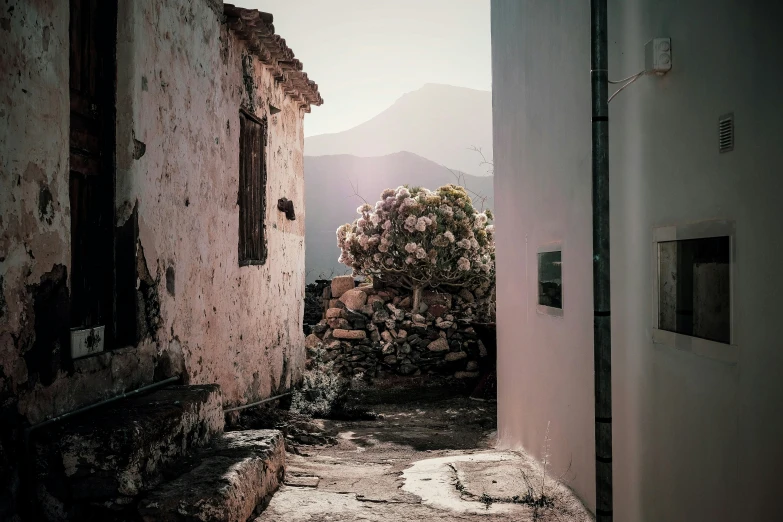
223 4 324 112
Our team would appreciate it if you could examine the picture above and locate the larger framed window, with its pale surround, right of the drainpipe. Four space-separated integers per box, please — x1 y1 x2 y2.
653 217 736 361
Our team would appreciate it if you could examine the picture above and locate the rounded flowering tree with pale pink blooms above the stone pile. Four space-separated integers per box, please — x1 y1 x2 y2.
337 185 495 311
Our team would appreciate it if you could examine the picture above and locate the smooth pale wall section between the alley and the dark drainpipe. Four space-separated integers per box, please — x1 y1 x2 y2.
492 0 595 505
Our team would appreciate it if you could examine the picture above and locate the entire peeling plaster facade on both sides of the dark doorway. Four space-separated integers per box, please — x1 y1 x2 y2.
0 0 305 434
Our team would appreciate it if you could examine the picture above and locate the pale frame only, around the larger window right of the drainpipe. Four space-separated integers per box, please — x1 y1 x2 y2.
652 220 738 363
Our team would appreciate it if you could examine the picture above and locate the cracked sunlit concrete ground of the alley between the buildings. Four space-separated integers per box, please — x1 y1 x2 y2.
255 382 592 522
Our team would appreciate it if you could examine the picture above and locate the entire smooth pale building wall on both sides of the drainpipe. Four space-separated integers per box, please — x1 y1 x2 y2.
492 0 783 522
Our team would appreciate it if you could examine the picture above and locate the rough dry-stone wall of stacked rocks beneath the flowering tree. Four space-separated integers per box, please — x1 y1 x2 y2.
306 276 486 379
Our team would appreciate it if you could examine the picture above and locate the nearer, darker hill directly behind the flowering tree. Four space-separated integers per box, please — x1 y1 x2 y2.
305 152 494 283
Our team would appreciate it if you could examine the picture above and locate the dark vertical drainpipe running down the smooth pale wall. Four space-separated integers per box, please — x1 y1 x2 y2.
590 0 612 522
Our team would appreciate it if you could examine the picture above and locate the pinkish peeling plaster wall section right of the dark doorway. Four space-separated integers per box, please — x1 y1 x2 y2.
116 0 304 404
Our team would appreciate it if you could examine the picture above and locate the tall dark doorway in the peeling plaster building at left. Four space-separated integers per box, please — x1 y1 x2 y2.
69 0 117 348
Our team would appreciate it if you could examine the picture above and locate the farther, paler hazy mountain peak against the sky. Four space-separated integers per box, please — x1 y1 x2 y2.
305 84 492 176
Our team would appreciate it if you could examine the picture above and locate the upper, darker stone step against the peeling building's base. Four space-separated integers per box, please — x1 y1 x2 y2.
33 385 224 520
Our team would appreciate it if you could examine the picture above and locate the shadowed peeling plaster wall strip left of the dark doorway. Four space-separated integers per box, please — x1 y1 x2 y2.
0 0 70 404
